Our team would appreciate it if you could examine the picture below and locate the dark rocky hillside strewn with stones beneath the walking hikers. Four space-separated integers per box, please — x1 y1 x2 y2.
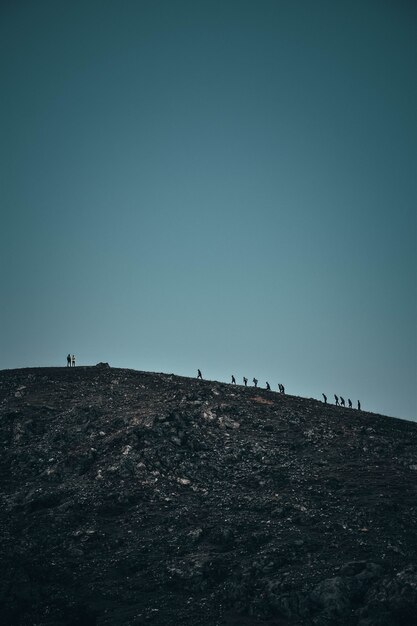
0 364 417 626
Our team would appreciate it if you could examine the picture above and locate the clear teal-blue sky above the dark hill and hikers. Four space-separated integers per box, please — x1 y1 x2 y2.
0 0 417 420
